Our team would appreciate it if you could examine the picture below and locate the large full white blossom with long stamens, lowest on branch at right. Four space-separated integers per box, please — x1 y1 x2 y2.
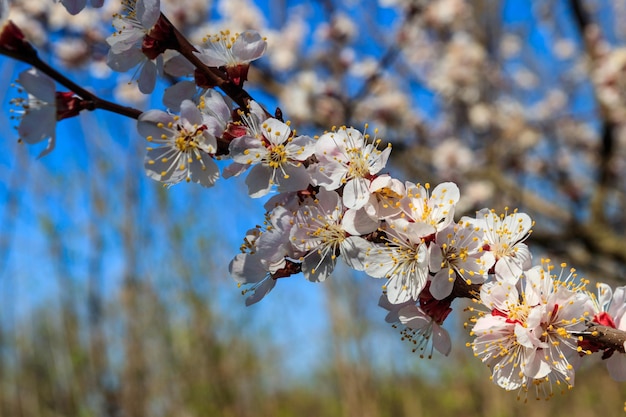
471 261 590 396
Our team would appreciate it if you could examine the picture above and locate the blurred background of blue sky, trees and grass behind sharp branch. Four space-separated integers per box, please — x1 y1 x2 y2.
0 0 626 417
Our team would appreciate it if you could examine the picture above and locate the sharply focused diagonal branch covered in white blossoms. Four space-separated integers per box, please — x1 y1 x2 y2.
0 0 626 402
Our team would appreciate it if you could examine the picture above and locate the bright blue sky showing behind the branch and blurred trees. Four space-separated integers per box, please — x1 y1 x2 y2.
0 1 616 382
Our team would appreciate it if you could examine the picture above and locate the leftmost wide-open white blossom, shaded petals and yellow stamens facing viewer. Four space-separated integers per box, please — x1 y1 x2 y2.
137 100 219 187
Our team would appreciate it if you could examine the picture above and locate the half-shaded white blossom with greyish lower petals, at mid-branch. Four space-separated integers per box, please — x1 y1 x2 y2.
229 118 315 198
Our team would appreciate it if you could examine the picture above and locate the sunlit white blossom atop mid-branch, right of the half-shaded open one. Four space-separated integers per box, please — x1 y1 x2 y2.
312 126 391 209
